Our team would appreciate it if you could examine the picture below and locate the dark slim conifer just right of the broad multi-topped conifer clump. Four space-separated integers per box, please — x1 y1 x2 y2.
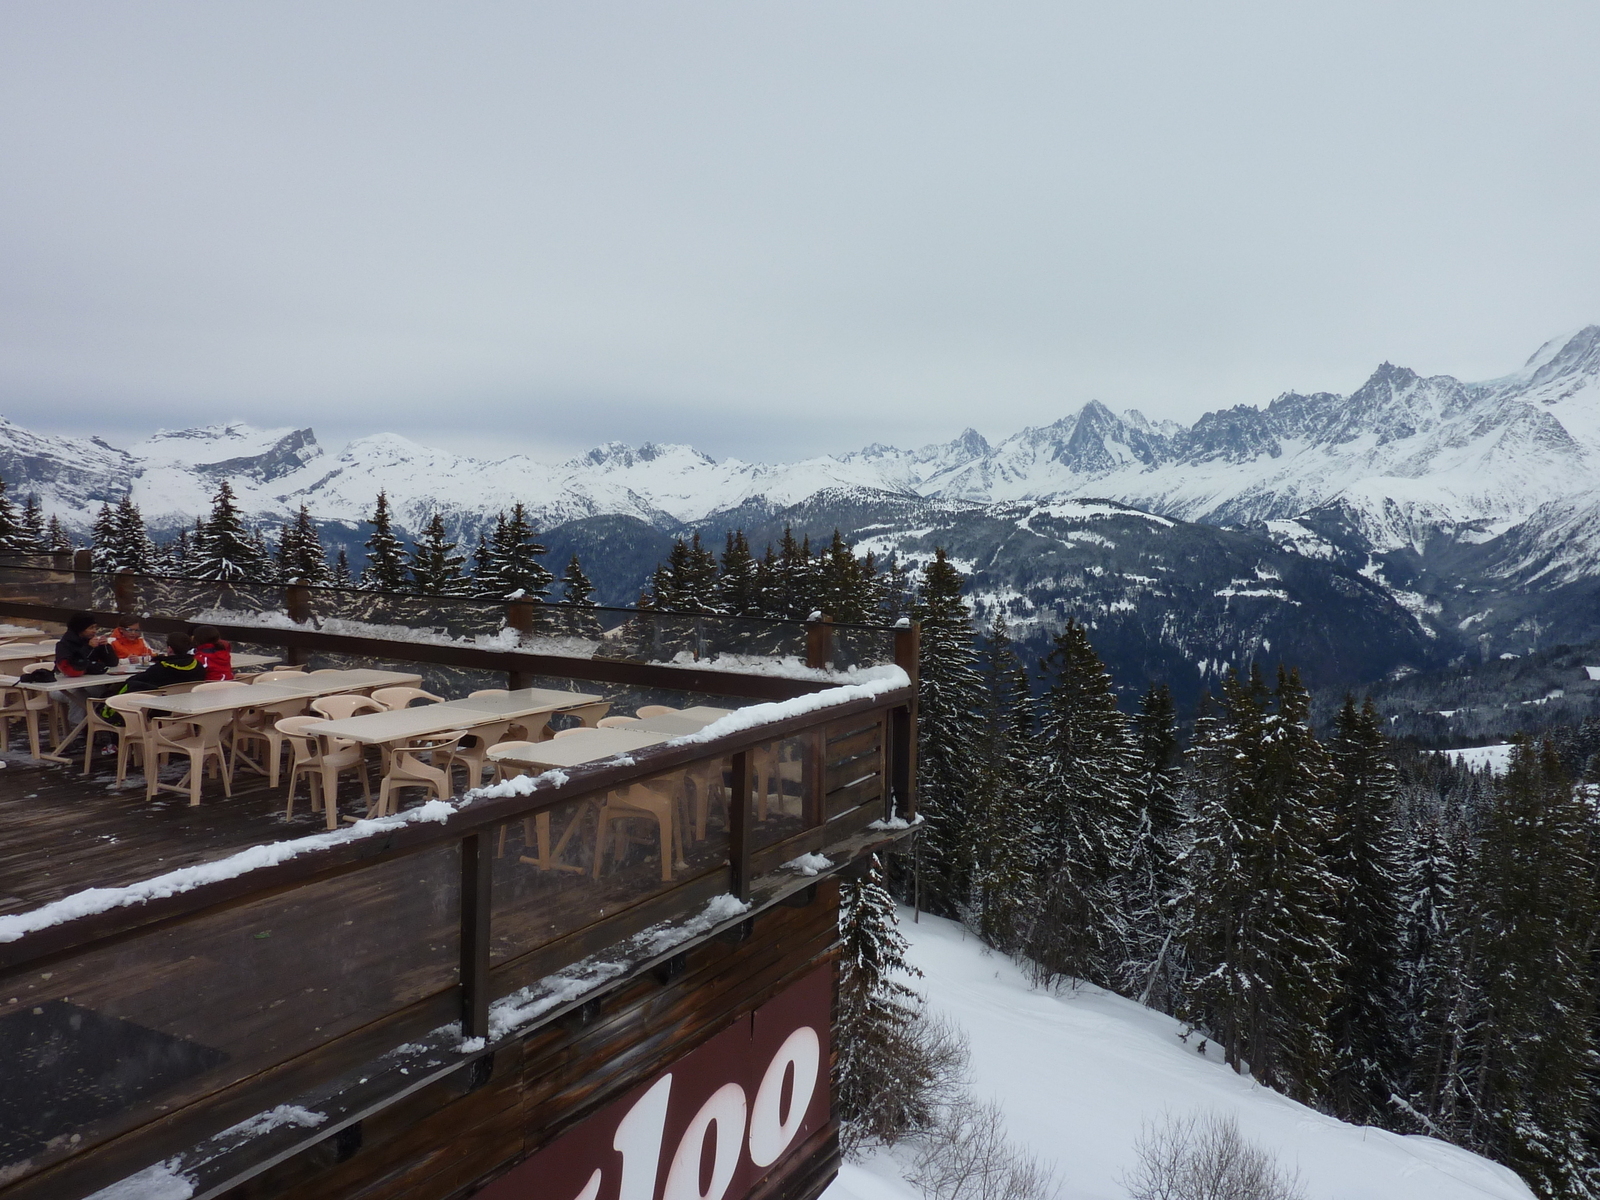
1328 696 1403 1125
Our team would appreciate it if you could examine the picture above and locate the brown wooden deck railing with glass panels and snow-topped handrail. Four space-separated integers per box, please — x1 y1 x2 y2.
0 571 917 1200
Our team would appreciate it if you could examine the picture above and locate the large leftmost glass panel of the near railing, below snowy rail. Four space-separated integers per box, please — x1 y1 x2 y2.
0 843 461 1178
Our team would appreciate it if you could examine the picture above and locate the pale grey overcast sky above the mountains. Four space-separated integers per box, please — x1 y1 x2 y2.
0 0 1600 459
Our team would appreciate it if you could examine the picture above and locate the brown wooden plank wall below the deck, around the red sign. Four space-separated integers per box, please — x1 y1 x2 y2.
226 878 838 1200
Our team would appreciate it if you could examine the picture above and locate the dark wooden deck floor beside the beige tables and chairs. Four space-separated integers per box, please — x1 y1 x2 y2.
0 739 376 914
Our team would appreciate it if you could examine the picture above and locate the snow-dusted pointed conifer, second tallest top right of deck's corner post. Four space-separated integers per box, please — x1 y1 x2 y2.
1027 621 1139 987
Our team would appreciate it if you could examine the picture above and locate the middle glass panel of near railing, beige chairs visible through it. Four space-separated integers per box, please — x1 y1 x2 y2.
491 761 728 987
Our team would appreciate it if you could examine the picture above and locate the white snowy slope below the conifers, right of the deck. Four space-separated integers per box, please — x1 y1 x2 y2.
824 912 1533 1200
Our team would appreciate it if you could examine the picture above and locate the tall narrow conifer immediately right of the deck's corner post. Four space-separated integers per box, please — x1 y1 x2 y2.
908 550 982 915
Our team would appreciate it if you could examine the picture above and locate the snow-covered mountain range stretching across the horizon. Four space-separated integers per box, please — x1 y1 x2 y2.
9 325 1600 710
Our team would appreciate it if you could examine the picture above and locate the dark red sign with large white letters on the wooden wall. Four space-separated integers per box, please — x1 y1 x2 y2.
478 966 834 1200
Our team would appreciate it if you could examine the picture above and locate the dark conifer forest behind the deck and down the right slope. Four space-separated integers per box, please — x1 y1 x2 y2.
12 482 1600 1197
